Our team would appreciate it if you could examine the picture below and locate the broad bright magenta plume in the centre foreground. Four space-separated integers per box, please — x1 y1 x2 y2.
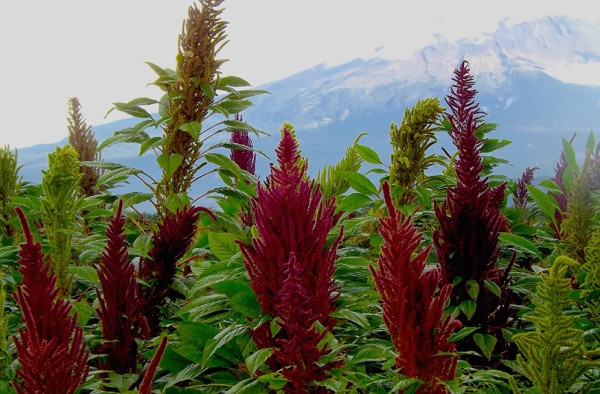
240 128 341 387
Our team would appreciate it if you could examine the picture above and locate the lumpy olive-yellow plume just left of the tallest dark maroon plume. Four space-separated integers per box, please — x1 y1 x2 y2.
390 98 444 205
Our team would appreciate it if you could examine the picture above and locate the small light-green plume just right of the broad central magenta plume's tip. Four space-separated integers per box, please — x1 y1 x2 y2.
317 134 364 200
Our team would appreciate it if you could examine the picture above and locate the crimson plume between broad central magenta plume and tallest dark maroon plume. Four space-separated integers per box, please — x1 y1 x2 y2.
370 182 461 393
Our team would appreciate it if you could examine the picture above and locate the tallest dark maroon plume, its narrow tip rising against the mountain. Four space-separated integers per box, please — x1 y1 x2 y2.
433 62 507 330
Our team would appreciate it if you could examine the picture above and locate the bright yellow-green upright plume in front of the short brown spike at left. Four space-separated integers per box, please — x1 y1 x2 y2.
41 145 81 296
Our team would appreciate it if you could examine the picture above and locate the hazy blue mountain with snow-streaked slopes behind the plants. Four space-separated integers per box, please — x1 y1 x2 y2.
18 16 600 194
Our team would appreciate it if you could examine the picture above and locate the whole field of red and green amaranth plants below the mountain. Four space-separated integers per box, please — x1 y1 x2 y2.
0 0 600 394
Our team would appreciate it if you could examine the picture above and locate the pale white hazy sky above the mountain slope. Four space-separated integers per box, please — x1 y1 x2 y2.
0 0 600 148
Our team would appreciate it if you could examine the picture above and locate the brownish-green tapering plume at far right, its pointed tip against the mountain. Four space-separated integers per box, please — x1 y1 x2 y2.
560 151 595 263
